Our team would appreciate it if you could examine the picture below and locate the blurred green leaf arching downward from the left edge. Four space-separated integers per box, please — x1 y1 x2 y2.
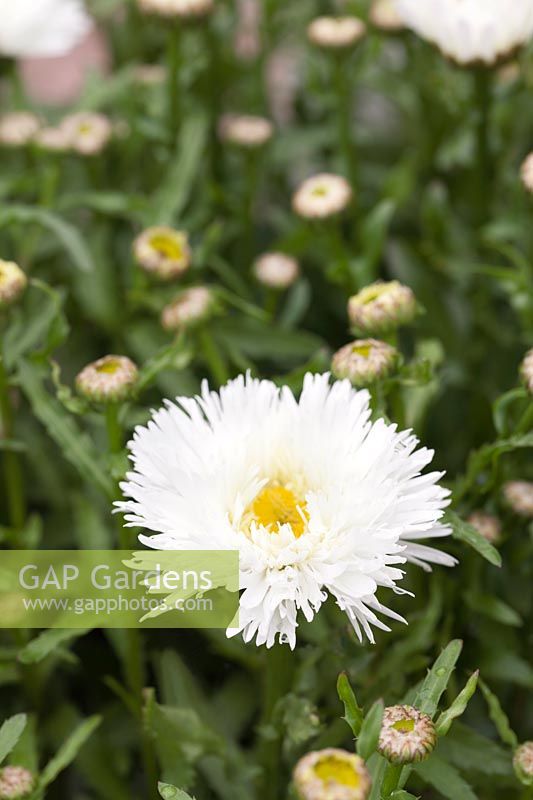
0 205 94 272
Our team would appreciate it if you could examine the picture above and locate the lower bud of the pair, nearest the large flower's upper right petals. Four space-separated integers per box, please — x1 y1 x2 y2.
331 339 399 388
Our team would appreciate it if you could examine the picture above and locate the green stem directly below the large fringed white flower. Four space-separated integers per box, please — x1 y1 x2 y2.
259 643 293 800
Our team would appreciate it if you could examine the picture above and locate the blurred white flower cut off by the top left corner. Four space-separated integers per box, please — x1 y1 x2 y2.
0 0 93 57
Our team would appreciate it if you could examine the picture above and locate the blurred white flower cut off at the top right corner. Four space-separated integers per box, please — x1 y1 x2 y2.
396 0 533 64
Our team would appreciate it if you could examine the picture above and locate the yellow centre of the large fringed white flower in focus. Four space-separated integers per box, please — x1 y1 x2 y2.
247 484 309 539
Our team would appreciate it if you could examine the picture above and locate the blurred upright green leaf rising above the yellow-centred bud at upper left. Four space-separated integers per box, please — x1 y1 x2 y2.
147 113 208 225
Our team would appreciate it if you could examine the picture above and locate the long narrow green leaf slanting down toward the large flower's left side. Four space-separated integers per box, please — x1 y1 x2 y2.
18 362 115 499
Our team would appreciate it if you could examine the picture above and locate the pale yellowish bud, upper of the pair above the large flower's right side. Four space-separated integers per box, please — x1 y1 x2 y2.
348 281 418 335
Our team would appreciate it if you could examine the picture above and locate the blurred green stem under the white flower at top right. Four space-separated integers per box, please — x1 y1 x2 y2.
474 67 493 224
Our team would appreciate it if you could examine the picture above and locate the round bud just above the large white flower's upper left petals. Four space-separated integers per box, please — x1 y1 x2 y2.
76 356 138 403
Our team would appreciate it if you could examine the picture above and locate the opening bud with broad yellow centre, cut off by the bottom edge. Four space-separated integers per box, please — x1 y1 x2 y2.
293 747 371 800
